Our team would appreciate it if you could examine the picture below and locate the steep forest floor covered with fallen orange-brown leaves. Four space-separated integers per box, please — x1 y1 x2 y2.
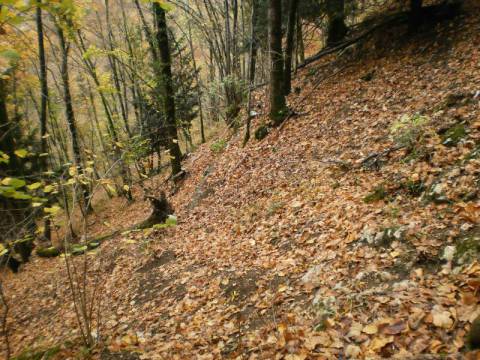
3 1 480 359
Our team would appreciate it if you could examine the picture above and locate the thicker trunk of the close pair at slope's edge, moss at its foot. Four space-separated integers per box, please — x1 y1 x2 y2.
268 0 287 126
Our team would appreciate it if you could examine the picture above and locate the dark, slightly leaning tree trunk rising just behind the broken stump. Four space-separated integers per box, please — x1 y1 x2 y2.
153 2 182 177
